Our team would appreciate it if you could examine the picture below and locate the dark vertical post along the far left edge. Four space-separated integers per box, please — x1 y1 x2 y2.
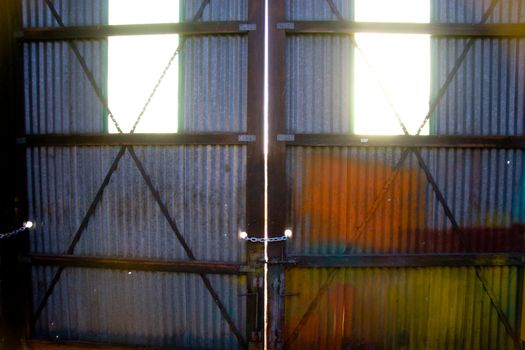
0 0 31 349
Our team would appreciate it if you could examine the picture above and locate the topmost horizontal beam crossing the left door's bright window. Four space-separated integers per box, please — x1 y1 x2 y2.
15 21 255 41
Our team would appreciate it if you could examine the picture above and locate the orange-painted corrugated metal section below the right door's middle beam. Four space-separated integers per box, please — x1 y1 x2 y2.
288 147 426 255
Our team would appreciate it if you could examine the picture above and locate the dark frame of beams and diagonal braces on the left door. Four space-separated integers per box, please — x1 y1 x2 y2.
19 0 264 349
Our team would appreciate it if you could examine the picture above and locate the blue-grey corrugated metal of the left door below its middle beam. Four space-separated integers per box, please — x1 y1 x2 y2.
28 146 246 349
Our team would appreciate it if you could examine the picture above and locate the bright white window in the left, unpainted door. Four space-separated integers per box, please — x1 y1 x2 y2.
108 0 179 133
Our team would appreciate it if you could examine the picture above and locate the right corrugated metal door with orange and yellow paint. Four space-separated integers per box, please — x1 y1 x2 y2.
267 0 525 349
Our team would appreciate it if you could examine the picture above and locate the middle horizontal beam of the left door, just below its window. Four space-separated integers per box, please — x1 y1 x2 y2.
17 133 255 147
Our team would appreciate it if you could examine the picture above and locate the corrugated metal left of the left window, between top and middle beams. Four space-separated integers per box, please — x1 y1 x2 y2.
24 41 107 134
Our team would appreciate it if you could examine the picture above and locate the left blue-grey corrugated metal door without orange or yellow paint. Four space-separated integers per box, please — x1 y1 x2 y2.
17 0 264 349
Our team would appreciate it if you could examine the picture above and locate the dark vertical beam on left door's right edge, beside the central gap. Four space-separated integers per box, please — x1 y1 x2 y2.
241 0 264 348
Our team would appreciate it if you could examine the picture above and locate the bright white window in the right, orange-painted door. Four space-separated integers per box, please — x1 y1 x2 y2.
354 0 430 135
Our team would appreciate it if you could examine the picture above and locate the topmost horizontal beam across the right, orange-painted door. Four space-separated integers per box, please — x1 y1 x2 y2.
277 21 525 37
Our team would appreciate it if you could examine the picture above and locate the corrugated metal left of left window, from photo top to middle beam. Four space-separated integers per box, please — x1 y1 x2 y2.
22 0 107 134
